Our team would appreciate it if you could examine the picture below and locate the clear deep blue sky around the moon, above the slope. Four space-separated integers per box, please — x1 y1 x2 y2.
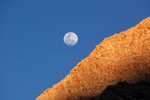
0 0 150 100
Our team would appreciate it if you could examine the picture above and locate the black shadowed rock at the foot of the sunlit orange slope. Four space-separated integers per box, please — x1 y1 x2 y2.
98 79 150 100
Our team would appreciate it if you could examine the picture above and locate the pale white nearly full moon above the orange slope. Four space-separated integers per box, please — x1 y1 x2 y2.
64 32 78 46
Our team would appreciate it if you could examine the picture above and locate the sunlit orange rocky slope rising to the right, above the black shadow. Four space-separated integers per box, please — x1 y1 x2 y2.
36 17 150 100
